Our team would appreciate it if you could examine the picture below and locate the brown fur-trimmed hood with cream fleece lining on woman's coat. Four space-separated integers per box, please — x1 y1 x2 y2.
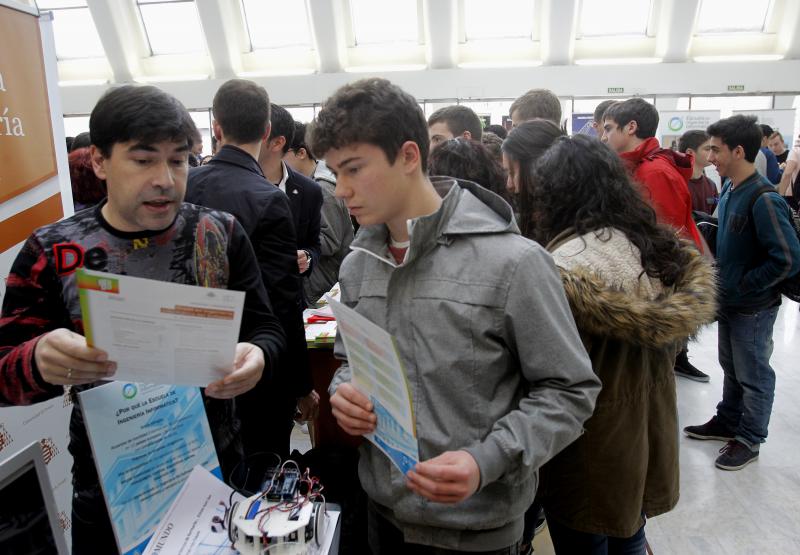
548 228 716 346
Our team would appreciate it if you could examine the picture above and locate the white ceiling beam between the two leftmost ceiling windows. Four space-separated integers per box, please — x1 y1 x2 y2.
86 0 149 83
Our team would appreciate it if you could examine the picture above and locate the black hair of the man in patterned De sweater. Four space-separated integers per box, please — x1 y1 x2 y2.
89 85 195 157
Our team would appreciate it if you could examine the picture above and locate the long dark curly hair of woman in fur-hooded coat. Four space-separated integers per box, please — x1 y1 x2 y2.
520 135 691 286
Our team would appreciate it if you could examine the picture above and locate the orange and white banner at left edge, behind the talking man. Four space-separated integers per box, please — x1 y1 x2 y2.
0 0 73 545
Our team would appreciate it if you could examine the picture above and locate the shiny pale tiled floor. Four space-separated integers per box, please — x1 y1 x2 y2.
292 299 800 555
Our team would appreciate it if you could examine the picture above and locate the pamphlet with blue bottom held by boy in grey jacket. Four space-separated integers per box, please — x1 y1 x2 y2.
328 299 419 474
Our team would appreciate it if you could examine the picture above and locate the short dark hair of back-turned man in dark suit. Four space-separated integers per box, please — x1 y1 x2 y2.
211 79 269 144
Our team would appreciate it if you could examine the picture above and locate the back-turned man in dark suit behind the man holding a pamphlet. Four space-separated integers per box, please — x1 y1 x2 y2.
186 79 316 458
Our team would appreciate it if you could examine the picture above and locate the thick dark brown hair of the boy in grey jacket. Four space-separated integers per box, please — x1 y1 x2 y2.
309 77 430 166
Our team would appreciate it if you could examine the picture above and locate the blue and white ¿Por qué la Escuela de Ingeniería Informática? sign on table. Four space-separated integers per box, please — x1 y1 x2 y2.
80 381 221 555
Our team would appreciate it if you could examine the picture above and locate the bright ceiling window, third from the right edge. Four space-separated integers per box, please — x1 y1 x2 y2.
464 0 535 40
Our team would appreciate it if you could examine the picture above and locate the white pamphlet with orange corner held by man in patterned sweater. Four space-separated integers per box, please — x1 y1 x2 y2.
77 269 244 387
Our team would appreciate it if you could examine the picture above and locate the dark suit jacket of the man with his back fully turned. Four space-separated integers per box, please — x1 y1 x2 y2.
186 145 311 398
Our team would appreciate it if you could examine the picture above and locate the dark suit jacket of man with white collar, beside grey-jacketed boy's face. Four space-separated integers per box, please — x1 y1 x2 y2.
284 164 322 276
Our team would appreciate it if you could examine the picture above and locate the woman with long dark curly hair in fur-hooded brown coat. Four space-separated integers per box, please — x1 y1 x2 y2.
512 133 715 554
